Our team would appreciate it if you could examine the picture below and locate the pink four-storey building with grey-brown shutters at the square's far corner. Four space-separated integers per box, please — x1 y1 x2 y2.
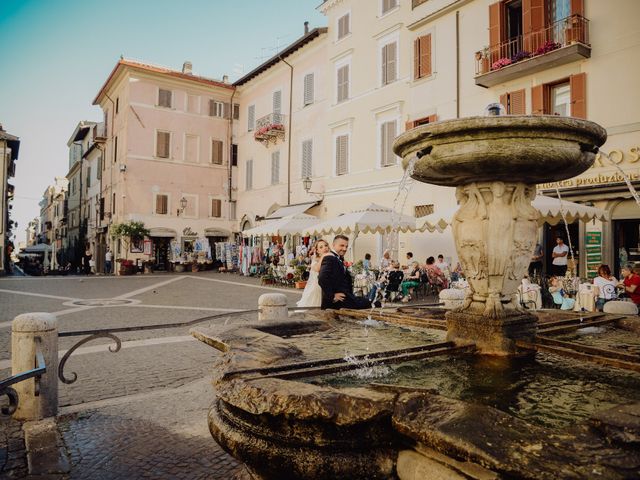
93 59 239 269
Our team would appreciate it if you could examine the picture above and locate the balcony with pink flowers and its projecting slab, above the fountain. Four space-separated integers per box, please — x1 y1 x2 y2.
475 15 591 88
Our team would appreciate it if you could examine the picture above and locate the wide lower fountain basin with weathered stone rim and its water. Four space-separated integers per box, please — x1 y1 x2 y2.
192 314 640 480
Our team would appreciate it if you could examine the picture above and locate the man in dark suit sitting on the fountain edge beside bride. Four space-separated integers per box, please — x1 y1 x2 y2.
318 235 378 310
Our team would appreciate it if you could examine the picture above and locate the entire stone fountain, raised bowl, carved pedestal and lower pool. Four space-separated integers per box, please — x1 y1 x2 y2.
191 116 640 480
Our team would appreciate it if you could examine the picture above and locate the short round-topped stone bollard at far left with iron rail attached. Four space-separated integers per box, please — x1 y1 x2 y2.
11 312 58 420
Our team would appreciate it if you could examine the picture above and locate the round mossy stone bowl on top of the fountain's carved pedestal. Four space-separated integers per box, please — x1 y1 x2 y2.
393 115 607 187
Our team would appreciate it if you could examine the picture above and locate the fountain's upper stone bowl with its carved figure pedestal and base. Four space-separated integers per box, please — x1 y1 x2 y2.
394 116 607 354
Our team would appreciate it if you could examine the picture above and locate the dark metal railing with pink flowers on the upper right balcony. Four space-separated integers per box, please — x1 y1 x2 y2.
475 15 589 75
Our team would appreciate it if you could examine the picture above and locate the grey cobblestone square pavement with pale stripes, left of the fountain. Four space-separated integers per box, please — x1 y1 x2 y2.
0 273 301 479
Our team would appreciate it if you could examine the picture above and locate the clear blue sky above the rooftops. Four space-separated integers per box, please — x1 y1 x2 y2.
0 0 326 241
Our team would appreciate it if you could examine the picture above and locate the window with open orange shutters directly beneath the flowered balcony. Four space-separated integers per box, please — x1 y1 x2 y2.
531 73 587 118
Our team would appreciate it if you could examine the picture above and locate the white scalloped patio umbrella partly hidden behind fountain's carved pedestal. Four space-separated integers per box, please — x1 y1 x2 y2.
416 195 607 232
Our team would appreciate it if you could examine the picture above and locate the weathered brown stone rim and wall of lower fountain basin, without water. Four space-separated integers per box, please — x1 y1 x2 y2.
192 313 640 480
